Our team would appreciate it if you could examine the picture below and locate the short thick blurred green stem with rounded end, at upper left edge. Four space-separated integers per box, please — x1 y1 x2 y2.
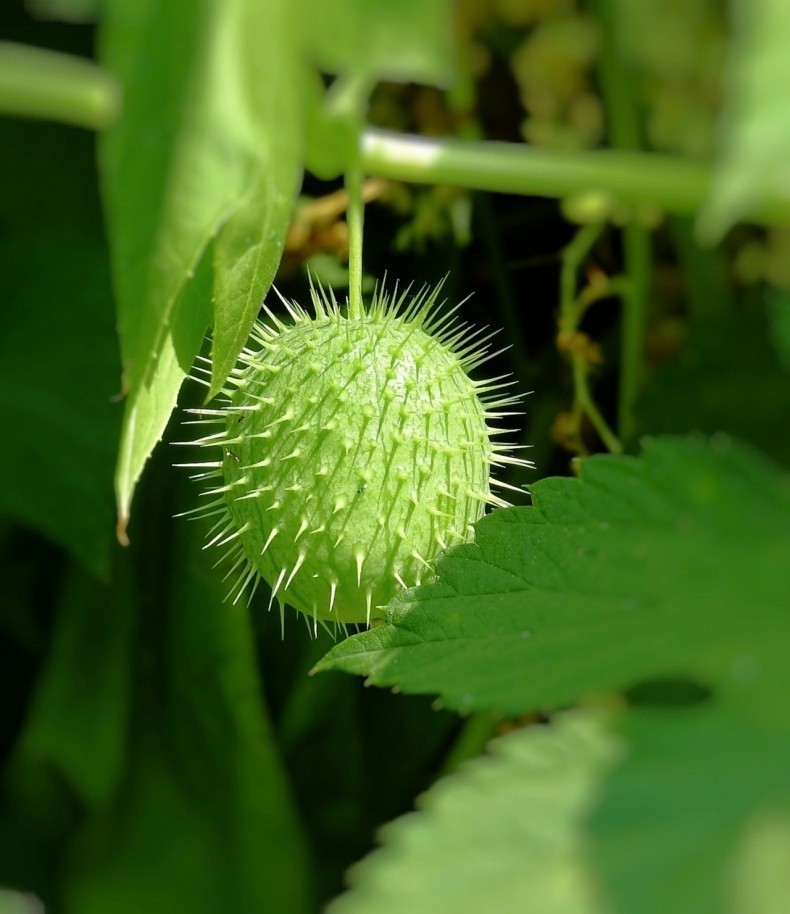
0 41 121 130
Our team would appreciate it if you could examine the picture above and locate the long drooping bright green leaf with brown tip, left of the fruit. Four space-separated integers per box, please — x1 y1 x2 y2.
101 0 300 518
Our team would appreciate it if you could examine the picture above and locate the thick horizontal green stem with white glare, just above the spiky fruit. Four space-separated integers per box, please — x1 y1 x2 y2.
362 128 790 225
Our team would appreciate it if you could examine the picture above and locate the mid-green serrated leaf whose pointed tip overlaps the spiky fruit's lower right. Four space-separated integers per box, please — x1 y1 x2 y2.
318 438 790 713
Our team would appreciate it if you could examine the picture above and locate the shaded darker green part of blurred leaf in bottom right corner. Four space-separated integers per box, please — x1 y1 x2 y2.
589 701 790 914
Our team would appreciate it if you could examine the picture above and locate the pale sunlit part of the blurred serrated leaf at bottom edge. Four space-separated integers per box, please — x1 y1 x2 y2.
329 712 618 914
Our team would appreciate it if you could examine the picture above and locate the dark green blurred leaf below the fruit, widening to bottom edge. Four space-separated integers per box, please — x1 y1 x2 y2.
63 493 311 914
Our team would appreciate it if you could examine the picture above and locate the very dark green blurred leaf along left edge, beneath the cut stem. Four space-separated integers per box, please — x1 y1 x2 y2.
0 122 120 574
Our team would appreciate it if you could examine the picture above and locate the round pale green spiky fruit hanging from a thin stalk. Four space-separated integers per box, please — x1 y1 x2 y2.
181 289 526 623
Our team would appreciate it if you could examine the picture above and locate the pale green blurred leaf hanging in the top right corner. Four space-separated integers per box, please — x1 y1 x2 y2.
697 0 790 242
